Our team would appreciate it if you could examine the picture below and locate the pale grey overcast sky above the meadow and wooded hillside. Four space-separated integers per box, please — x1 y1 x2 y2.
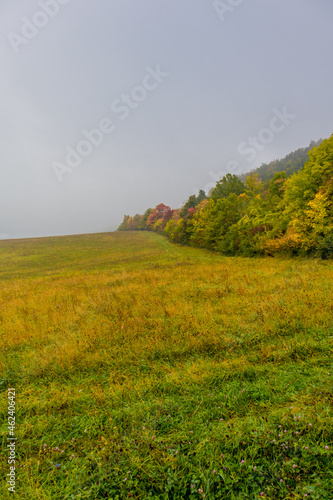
0 0 333 238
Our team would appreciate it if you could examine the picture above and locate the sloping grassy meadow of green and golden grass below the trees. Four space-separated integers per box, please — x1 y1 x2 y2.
0 232 333 500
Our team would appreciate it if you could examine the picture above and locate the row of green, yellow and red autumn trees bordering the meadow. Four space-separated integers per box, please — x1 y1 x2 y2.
118 135 333 258
